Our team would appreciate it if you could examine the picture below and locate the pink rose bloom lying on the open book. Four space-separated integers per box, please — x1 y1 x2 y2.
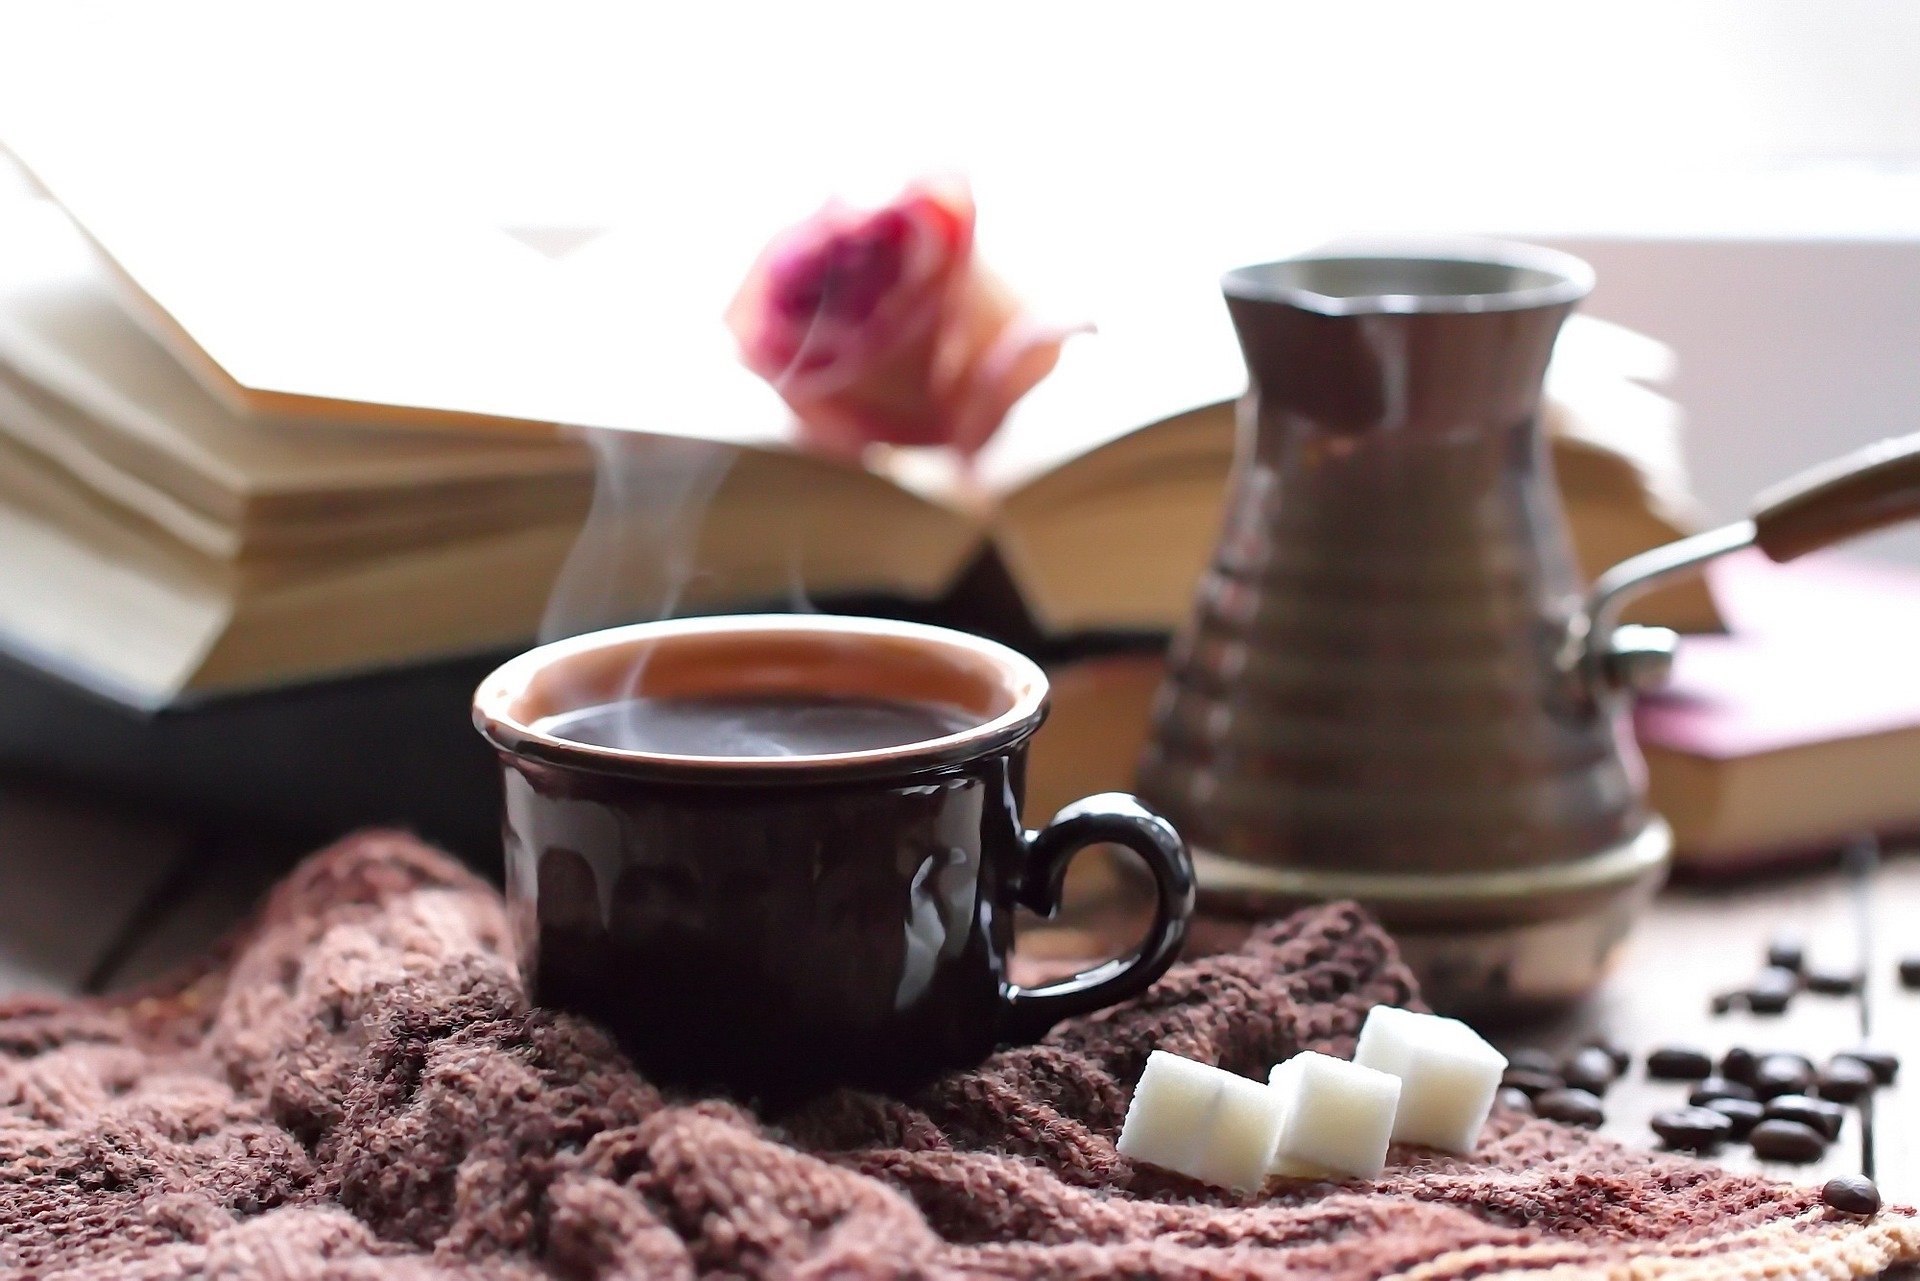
726 181 1071 457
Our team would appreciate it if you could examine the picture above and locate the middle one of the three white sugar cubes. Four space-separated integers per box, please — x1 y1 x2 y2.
1267 1051 1400 1179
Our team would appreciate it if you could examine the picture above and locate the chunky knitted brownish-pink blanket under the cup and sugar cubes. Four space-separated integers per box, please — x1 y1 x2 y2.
0 834 1920 1281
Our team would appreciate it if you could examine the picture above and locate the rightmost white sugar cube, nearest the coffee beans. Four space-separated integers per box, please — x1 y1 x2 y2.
1354 1004 1507 1154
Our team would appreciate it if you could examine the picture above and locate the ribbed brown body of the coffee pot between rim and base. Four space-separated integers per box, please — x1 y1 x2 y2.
1140 253 1645 891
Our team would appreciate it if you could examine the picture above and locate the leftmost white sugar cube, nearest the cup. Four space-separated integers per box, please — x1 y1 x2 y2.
1119 1051 1284 1193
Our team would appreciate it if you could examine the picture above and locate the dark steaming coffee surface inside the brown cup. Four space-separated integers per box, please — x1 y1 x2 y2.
534 693 979 757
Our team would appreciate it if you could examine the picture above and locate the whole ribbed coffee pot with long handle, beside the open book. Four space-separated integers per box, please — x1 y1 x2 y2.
1139 242 1920 1016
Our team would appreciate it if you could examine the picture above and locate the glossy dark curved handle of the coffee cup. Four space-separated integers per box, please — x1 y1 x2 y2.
1006 791 1194 1041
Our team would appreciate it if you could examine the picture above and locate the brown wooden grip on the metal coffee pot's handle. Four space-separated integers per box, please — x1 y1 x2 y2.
1753 434 1920 561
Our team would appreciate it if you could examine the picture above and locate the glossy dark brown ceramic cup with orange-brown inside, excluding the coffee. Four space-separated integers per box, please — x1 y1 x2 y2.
474 615 1194 1099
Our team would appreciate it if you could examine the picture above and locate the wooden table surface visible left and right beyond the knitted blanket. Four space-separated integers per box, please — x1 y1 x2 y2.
0 782 1920 1259
